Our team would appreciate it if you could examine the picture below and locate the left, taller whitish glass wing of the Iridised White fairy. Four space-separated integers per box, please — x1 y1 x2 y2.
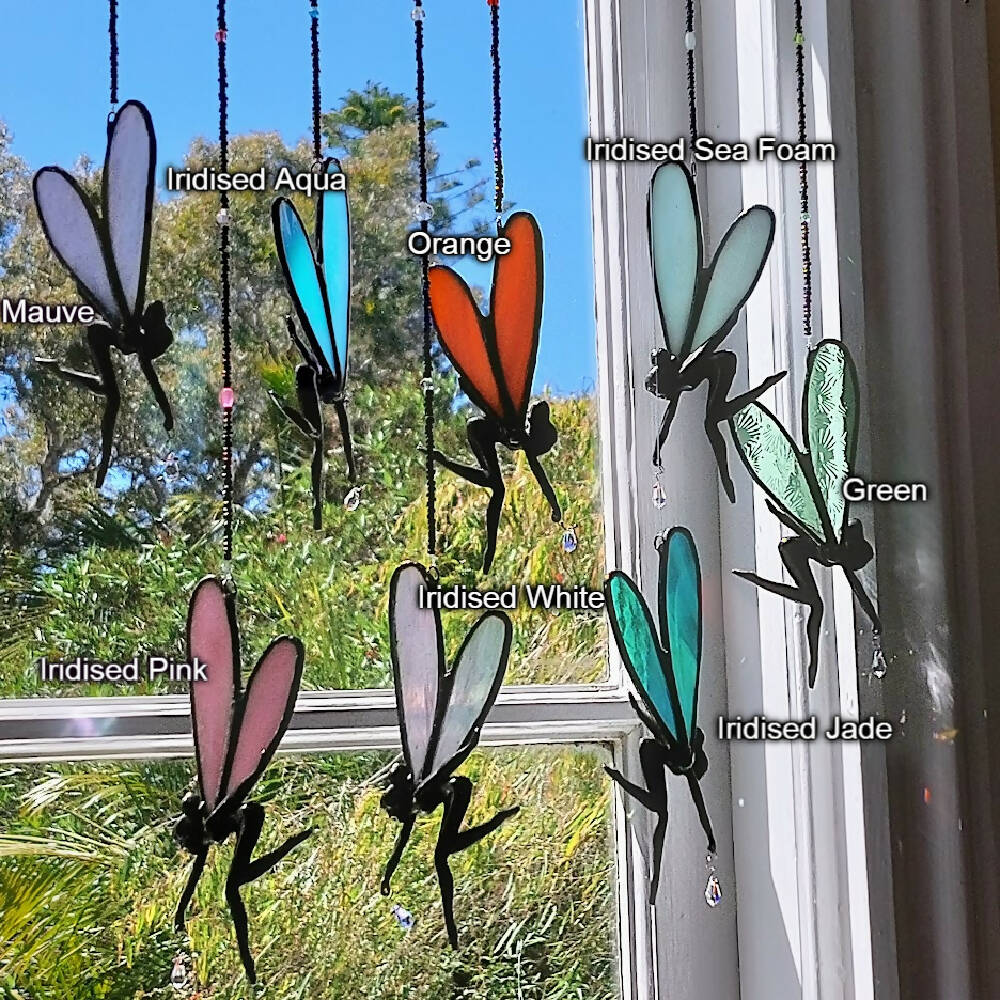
389 563 444 781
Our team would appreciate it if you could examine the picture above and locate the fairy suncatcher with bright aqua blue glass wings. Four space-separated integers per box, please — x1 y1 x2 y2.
270 157 357 528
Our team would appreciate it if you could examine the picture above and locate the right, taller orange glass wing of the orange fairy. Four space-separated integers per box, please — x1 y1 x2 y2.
490 212 542 417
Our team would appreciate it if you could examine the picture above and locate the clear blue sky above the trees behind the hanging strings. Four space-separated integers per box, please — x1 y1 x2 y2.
0 0 595 392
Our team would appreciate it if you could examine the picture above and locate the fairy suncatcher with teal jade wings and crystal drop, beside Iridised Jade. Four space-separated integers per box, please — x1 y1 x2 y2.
604 528 721 906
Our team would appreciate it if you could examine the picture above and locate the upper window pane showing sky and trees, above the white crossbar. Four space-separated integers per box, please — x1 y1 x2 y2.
0 0 605 697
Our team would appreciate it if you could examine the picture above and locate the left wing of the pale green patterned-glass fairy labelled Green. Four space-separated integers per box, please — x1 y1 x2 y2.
731 403 826 542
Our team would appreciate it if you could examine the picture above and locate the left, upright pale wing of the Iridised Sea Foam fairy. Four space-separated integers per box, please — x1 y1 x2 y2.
649 163 701 357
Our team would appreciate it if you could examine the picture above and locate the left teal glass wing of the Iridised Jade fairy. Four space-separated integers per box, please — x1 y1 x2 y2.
604 571 682 739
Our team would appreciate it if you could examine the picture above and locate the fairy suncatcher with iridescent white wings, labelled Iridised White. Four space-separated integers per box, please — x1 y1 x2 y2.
382 563 518 948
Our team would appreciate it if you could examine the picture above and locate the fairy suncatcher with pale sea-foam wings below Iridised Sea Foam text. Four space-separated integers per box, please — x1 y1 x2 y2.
646 163 785 501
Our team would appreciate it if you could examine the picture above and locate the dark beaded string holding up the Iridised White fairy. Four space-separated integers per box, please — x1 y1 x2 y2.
410 0 437 574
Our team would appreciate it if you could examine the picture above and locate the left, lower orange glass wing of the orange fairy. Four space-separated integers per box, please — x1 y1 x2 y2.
428 266 504 422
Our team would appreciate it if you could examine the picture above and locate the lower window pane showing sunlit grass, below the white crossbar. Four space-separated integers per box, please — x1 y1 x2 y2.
0 749 619 1000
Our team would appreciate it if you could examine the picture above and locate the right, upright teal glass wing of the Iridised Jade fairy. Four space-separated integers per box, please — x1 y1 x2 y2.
660 528 701 739
